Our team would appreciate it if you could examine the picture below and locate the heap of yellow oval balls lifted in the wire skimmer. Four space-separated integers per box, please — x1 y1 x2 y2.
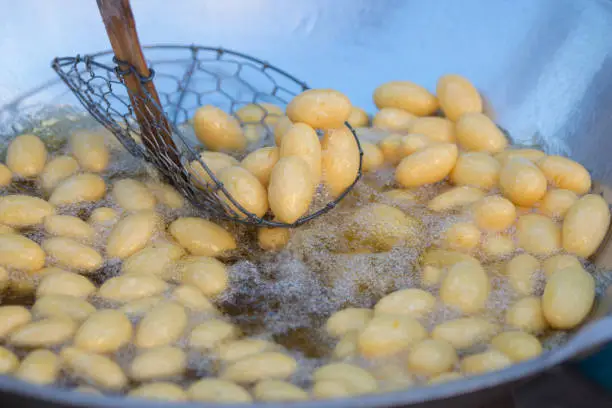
190 89 360 224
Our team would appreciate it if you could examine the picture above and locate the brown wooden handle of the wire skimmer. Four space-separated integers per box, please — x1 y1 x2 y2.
97 0 181 167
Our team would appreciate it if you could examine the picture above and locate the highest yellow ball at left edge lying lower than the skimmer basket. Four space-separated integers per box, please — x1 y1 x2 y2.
0 234 45 273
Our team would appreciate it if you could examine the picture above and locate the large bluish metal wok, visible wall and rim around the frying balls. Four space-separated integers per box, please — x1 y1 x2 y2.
0 0 612 408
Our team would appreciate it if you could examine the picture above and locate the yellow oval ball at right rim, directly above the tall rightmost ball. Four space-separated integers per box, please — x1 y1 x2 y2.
537 156 591 195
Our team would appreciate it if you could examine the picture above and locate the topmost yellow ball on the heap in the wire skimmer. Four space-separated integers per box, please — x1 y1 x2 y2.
287 89 352 129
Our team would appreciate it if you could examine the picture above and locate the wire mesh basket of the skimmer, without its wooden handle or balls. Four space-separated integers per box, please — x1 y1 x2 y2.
51 45 363 227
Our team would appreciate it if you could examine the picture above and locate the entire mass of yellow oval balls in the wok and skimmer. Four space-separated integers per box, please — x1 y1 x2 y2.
0 75 610 402
